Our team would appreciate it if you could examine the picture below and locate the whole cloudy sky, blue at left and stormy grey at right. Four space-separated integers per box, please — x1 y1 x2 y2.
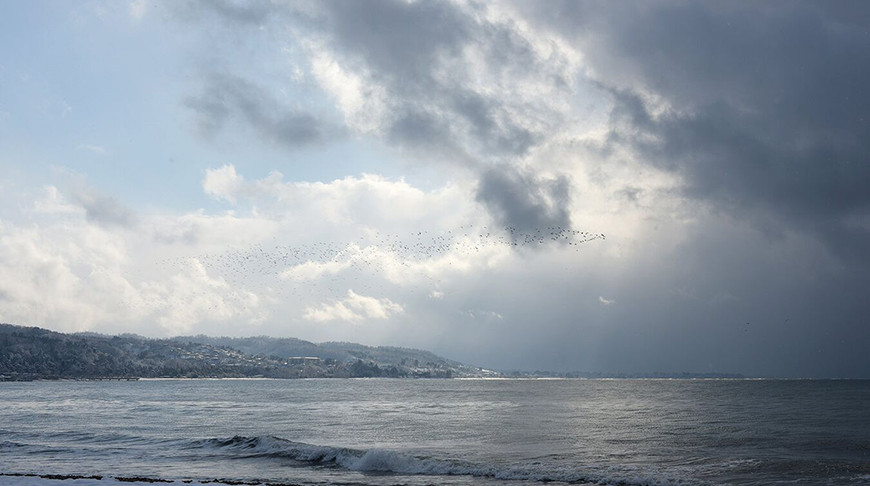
0 0 870 378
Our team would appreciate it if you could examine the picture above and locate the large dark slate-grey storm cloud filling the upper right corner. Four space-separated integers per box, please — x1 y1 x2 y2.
521 2 870 258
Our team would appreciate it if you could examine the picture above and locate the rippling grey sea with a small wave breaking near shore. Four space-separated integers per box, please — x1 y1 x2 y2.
0 379 870 486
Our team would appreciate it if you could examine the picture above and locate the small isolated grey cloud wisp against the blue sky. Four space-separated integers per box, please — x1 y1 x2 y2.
184 74 338 148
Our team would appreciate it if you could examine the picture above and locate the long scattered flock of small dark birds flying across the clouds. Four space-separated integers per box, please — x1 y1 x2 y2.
153 226 605 295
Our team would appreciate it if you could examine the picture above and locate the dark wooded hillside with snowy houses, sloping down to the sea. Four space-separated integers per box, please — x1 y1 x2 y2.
0 324 487 381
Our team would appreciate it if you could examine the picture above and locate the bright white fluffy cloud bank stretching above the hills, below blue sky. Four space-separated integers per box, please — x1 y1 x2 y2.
0 165 528 335
